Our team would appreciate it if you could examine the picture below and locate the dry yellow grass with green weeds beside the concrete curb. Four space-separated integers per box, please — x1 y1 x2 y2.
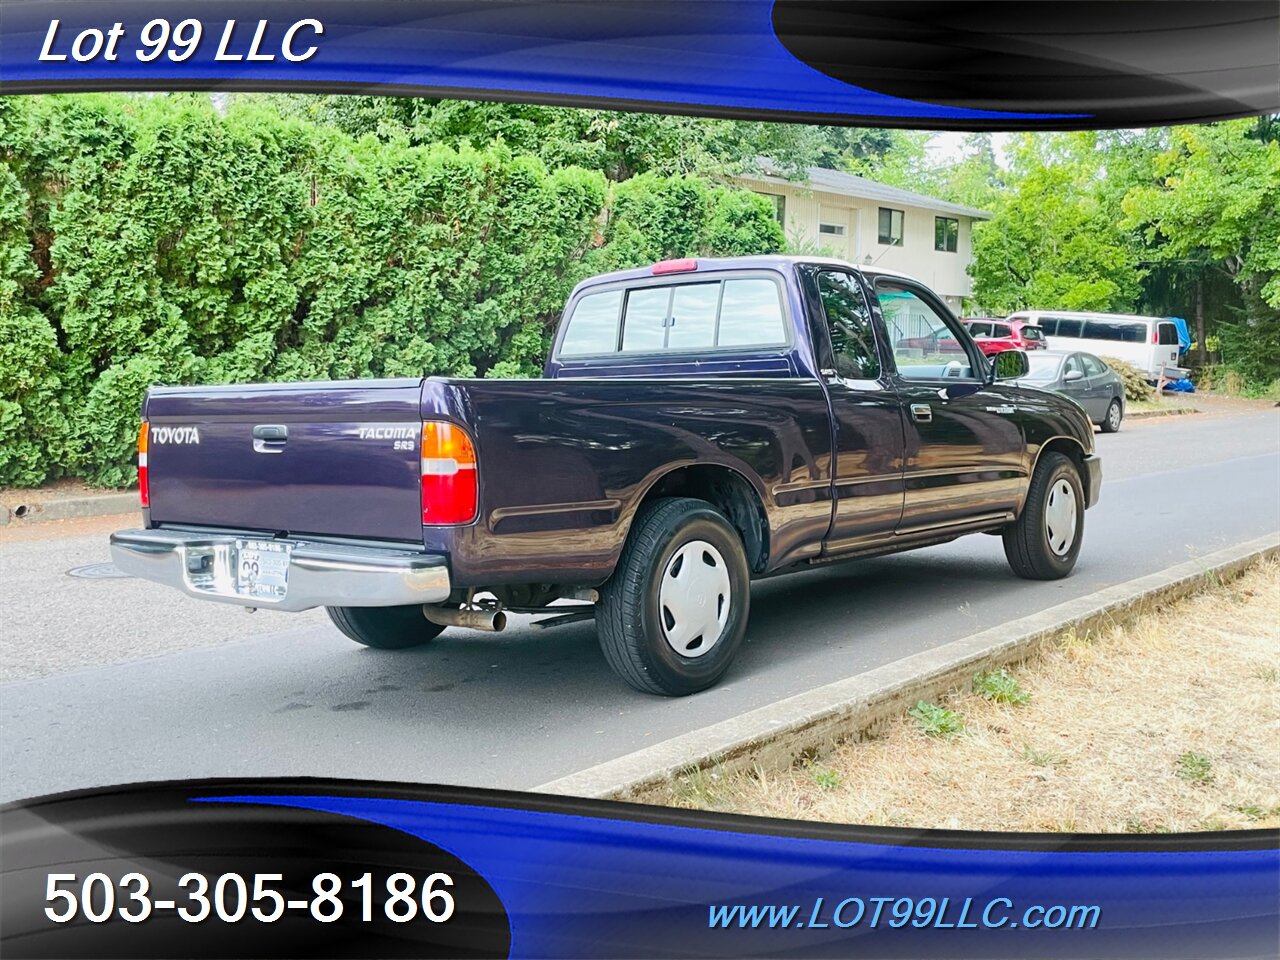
671 561 1280 833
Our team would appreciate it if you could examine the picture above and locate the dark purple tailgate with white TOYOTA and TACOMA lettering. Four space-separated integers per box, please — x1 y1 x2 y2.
143 379 422 543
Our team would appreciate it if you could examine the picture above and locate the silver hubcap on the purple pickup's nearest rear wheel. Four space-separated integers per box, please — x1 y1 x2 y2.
658 540 732 657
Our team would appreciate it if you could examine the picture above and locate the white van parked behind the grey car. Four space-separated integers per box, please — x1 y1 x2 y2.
1009 310 1178 380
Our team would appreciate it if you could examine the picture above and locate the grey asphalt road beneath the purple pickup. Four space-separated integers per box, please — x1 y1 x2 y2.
0 410 1280 800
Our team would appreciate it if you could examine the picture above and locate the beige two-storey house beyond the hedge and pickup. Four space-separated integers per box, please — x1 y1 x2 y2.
733 166 991 314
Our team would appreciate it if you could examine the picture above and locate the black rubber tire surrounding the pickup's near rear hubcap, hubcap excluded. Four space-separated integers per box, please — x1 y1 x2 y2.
595 497 751 696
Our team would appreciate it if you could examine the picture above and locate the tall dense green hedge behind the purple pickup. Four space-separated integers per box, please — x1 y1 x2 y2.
0 95 785 485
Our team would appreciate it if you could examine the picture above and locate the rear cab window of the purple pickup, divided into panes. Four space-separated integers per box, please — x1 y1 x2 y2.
558 274 788 360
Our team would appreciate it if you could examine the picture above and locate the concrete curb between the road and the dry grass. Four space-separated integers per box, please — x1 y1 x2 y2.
534 532 1280 803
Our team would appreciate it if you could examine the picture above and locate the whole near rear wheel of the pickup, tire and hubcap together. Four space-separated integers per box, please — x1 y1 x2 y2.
595 497 751 696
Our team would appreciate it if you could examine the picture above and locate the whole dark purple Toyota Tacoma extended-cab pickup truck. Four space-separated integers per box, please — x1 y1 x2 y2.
111 256 1102 695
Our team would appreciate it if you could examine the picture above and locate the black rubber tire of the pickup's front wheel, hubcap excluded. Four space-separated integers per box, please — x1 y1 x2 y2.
1004 451 1084 580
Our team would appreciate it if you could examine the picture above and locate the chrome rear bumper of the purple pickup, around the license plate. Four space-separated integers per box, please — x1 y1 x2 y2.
111 530 449 611
